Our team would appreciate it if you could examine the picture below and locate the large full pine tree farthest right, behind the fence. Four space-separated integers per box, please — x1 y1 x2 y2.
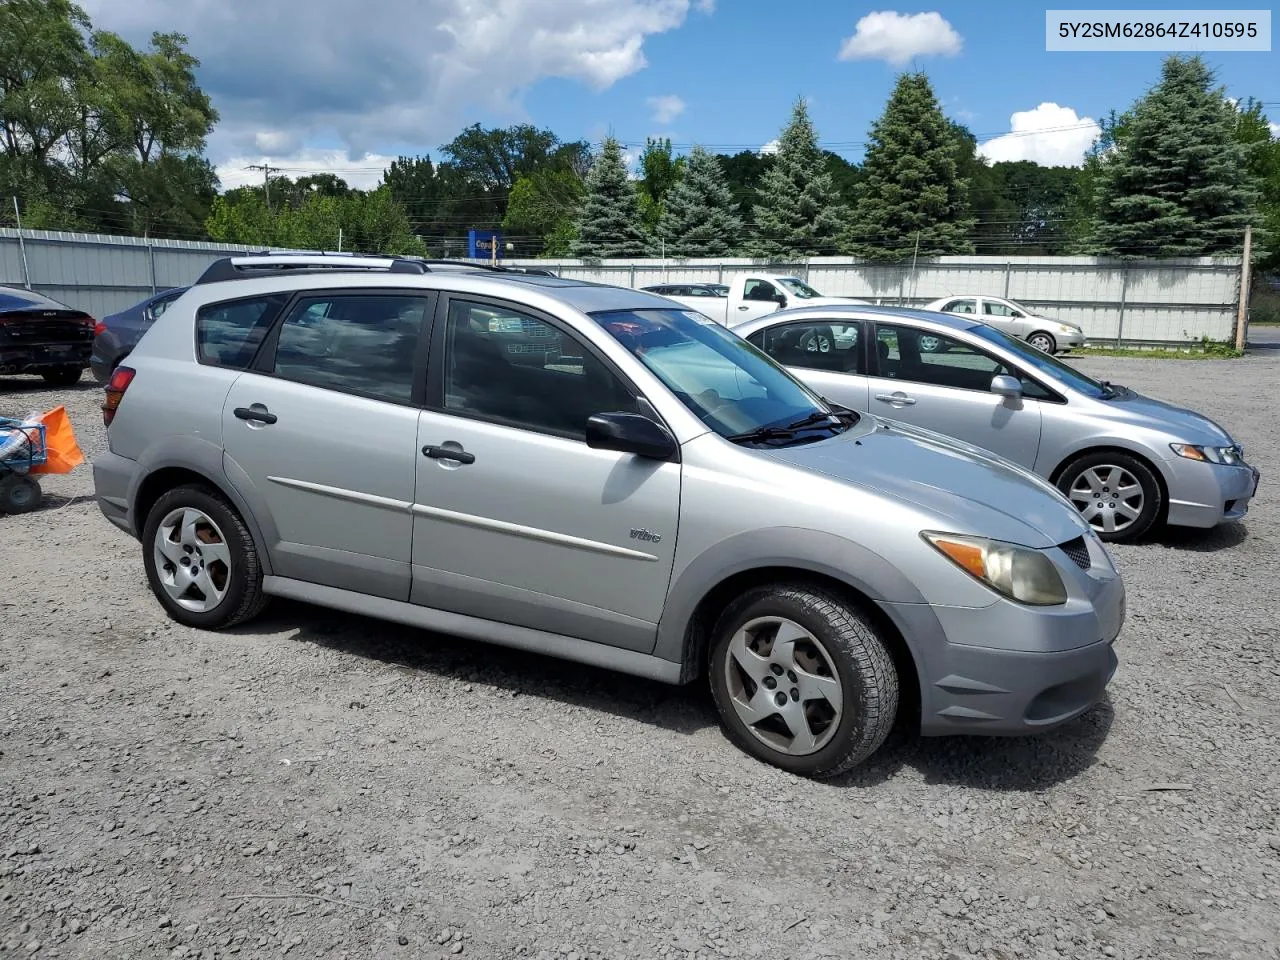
1091 55 1257 257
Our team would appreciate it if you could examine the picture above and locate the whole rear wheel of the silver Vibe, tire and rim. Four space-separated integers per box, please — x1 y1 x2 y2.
142 485 266 630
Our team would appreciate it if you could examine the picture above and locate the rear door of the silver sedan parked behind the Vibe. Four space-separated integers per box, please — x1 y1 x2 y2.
748 319 868 411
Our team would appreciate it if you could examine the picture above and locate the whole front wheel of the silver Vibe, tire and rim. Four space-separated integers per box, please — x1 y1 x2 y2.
710 584 899 777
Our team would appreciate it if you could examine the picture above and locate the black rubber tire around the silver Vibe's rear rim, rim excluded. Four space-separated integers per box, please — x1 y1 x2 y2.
142 485 270 630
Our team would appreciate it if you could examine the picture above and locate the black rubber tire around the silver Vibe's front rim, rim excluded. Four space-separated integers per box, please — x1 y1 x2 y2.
709 582 899 778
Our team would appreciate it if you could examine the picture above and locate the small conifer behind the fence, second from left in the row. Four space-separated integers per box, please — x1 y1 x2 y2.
658 147 742 257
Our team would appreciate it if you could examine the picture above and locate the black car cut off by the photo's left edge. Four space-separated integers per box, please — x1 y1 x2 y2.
0 287 95 387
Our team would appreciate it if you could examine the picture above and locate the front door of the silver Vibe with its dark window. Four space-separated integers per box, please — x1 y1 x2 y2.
411 294 680 652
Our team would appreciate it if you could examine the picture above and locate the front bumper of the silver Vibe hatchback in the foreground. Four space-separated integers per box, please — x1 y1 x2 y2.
888 563 1125 736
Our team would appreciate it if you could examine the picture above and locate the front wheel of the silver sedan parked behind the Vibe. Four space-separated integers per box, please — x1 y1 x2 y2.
1057 452 1164 543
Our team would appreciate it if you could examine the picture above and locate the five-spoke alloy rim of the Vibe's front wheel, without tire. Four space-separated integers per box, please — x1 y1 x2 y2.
724 617 844 756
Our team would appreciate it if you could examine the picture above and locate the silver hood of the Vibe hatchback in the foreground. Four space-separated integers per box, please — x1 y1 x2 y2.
762 417 1088 548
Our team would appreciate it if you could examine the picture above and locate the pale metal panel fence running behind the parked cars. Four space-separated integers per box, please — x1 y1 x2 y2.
0 228 1240 342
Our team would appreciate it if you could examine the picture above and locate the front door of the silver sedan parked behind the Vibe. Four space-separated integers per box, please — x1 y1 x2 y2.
868 323 1043 467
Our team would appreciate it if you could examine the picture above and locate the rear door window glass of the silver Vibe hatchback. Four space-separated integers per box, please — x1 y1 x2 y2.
273 294 430 403
